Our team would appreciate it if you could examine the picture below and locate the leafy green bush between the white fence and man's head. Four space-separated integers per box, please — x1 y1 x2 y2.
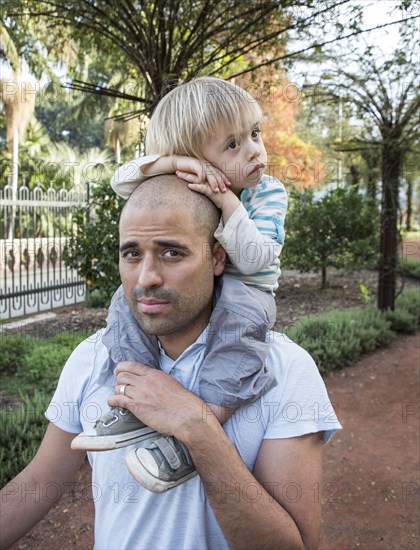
64 181 124 305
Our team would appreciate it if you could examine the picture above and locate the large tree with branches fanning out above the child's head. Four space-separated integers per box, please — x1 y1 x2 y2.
4 0 374 118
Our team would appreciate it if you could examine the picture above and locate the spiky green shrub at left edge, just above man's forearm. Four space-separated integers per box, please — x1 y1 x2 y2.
0 391 51 487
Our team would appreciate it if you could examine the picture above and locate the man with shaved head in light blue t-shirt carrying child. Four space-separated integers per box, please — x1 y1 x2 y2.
0 176 339 550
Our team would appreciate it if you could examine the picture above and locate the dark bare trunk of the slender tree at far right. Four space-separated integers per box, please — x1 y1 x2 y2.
378 137 402 310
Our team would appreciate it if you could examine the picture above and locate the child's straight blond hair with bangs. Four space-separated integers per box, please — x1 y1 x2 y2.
146 77 264 160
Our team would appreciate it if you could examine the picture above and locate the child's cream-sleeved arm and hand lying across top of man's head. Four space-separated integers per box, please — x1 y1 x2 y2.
111 155 230 199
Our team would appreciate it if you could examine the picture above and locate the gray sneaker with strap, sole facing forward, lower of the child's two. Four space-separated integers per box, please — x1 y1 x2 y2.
125 436 197 493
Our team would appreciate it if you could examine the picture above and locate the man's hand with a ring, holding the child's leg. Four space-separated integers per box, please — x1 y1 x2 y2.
108 361 206 441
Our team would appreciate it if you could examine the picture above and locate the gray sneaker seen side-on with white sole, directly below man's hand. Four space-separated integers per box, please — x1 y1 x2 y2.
71 407 158 451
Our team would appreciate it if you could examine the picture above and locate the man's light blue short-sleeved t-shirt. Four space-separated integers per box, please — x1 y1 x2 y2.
46 331 341 550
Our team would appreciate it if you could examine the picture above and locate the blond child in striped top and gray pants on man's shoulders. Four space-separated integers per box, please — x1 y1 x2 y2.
72 77 287 492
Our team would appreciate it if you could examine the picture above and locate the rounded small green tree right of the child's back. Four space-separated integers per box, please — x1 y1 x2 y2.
283 188 379 286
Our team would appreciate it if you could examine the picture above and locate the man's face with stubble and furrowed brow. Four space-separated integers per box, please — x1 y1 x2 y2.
120 206 223 354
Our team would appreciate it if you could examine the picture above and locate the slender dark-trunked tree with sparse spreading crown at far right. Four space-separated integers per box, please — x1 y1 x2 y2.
324 47 420 309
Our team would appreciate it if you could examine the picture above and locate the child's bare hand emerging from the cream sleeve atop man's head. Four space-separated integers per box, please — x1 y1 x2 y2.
173 156 231 193
